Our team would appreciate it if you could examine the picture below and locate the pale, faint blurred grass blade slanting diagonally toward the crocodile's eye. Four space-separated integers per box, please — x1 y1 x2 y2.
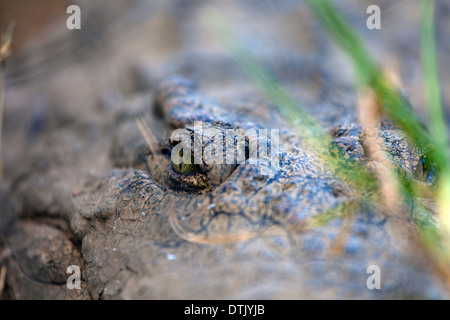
203 8 377 196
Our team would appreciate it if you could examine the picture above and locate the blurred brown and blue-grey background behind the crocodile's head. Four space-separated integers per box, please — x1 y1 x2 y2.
0 0 450 300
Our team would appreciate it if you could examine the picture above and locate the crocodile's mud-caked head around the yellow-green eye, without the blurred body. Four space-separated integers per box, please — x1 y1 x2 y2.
1 67 442 298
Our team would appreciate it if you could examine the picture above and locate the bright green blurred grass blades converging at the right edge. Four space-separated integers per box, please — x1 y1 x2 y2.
304 0 450 276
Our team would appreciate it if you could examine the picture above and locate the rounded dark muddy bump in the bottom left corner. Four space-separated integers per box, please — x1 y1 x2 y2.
3 222 89 299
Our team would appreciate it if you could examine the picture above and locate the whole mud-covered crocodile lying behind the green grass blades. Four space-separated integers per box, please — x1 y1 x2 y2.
0 0 446 299
